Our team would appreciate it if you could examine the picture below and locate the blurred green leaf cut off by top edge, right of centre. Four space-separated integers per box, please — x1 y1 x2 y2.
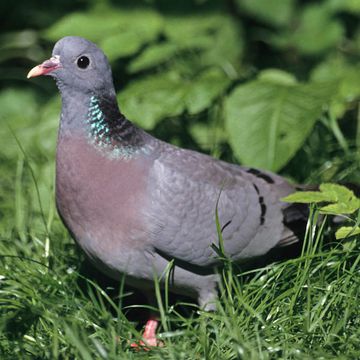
237 0 295 26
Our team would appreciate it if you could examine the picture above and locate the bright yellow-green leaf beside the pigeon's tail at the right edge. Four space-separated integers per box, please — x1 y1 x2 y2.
282 183 360 215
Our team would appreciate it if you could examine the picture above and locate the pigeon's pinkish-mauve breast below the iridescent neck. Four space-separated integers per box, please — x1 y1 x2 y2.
56 138 150 270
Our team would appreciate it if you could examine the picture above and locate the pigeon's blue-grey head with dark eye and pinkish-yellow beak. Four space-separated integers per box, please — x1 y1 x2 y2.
28 36 114 94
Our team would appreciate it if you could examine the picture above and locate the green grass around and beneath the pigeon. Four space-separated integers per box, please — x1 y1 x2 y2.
0 99 360 359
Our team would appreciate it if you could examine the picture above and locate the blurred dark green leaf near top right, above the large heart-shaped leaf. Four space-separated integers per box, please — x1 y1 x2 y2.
270 4 345 55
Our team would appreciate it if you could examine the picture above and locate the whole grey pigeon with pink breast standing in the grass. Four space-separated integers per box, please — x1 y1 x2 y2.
28 36 307 345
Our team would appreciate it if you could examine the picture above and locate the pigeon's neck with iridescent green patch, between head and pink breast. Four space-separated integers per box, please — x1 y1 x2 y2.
59 92 146 157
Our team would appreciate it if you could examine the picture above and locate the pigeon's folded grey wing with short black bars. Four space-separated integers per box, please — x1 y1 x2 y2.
148 143 293 267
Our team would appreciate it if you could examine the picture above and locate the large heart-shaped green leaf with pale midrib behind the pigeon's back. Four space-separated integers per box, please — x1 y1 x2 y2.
225 74 335 171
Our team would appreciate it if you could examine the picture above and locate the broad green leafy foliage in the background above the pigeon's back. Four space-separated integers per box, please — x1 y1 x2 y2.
35 0 360 170
